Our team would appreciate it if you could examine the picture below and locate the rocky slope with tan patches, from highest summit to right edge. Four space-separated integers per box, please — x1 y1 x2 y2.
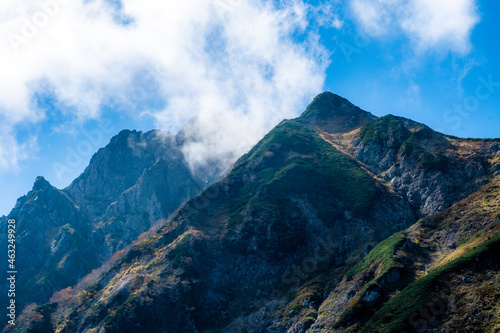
300 92 500 217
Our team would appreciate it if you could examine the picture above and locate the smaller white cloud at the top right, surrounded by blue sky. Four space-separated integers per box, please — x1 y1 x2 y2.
351 0 479 54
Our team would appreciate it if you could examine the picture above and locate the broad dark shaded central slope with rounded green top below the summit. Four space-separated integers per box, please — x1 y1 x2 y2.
11 121 415 332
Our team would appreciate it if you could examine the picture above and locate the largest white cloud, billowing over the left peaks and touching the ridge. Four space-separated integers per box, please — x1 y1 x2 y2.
0 0 327 174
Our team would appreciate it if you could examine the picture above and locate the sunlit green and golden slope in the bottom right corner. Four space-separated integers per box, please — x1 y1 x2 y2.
310 180 500 332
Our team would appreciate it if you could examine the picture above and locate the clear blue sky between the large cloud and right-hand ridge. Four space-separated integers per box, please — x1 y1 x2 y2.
325 1 500 137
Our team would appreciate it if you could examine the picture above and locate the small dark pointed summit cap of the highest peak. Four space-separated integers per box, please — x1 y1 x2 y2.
299 92 376 133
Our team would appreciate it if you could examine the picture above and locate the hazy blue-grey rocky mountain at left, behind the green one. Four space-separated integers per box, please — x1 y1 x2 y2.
0 130 215 322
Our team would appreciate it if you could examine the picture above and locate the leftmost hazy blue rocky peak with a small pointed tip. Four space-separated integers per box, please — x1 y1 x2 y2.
0 177 100 308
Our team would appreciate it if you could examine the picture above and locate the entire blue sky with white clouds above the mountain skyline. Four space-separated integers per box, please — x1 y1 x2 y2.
0 0 500 215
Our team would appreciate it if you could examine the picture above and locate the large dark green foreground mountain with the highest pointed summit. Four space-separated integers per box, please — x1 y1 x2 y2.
6 93 500 333
